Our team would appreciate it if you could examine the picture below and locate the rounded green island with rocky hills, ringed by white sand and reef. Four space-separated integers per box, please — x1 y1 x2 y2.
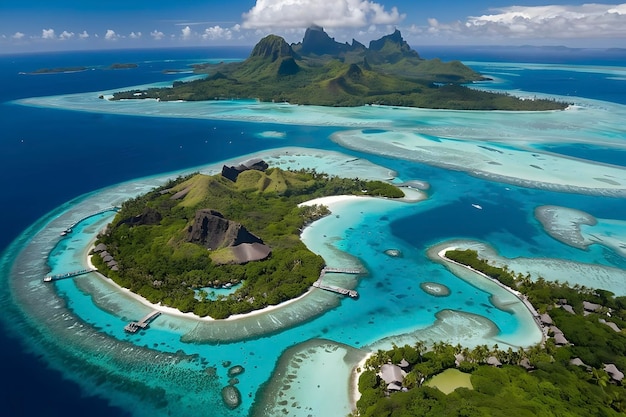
92 160 404 319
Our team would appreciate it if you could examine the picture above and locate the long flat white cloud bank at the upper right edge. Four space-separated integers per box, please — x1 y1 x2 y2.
426 3 626 41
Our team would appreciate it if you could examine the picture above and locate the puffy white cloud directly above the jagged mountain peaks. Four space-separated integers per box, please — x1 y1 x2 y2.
243 0 405 29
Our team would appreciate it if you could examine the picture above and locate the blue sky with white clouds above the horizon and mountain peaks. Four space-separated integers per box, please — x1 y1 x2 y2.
0 0 626 54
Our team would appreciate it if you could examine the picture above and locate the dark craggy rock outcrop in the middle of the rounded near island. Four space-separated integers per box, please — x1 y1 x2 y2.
187 209 263 250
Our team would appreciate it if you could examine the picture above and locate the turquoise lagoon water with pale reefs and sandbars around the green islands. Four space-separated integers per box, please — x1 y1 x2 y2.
1 49 626 417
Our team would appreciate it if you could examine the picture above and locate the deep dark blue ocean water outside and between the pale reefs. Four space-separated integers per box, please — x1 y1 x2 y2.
0 47 626 417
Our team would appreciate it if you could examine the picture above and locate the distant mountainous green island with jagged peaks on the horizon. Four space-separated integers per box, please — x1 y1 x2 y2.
111 27 567 111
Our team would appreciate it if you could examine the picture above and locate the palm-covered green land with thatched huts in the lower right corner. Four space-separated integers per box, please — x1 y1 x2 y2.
356 250 626 417
